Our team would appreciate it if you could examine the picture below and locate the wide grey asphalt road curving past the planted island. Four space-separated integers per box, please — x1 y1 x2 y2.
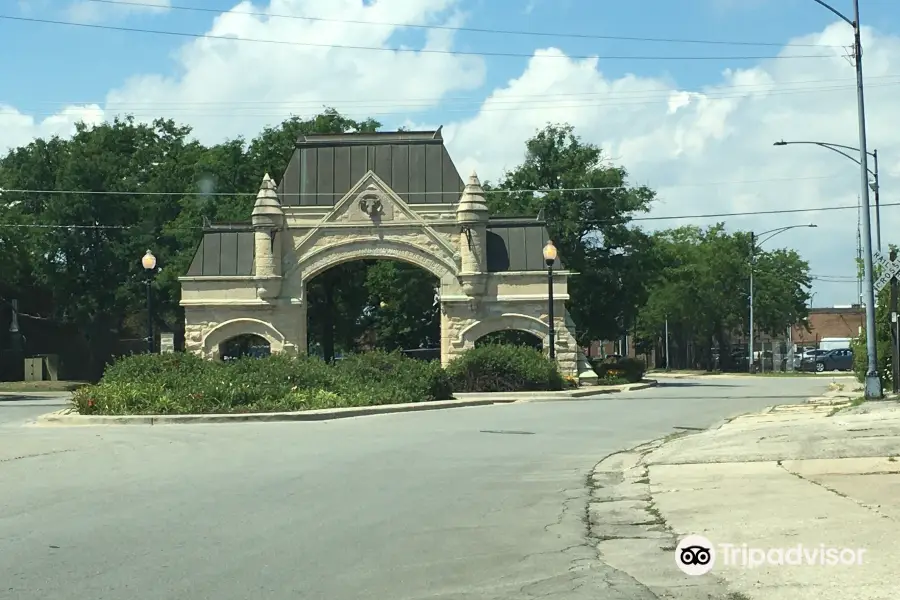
0 378 827 600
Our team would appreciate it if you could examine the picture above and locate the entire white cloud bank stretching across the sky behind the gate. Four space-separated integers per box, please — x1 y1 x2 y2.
0 0 900 303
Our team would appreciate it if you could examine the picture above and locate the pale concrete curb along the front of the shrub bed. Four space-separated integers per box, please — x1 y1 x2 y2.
34 398 515 426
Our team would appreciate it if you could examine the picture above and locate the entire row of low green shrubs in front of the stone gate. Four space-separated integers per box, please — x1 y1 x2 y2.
73 345 565 415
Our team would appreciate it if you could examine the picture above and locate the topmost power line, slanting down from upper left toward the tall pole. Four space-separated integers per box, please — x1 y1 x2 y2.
89 0 840 48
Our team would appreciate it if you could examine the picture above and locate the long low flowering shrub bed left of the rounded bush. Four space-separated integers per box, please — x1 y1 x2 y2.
73 352 451 415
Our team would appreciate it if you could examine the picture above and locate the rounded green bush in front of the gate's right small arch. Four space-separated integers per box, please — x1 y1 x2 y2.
447 344 564 392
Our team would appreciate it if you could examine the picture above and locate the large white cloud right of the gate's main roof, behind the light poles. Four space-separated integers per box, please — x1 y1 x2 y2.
445 23 900 303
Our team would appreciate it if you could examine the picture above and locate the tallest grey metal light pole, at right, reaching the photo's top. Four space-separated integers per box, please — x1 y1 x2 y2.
800 0 884 400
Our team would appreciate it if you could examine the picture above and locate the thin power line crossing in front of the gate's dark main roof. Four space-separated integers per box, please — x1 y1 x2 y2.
0 175 856 199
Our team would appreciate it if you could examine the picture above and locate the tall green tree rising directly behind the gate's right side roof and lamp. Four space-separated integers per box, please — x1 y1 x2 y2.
487 125 654 343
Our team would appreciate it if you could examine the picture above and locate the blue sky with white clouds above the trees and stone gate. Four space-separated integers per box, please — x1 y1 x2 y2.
0 0 900 305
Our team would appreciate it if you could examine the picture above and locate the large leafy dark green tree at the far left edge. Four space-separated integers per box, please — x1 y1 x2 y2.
0 118 199 374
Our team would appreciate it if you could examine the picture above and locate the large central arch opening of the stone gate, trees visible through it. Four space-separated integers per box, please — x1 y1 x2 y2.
306 259 441 362
